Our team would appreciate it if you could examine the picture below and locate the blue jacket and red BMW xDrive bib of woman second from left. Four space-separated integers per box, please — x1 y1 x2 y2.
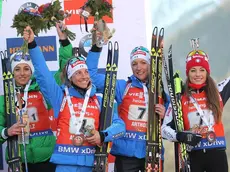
29 43 125 172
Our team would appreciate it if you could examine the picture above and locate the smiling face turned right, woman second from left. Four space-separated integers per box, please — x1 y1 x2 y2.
70 68 90 89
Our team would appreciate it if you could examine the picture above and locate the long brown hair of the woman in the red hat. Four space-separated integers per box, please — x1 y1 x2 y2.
184 74 223 123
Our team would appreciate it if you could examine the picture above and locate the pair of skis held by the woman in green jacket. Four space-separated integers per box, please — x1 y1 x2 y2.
0 50 21 172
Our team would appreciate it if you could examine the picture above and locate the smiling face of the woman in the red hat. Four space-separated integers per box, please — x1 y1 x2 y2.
188 66 207 85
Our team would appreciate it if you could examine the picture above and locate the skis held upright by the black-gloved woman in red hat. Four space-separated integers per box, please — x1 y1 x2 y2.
163 45 190 172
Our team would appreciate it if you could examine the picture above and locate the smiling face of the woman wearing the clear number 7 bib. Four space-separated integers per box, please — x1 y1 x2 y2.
131 59 149 82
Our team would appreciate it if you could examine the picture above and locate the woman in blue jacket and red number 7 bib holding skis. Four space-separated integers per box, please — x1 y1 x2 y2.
86 42 169 172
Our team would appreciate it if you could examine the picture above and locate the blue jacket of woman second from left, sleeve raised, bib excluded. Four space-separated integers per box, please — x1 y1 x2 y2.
29 47 125 167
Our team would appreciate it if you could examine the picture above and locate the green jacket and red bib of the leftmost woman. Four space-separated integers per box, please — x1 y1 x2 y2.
0 79 55 170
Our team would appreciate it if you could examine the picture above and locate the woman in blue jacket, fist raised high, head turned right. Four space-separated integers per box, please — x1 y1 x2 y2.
24 26 125 172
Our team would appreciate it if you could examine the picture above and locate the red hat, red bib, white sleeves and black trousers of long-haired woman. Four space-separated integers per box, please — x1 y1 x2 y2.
162 50 230 172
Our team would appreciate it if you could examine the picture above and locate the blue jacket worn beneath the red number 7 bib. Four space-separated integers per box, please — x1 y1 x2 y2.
86 51 169 159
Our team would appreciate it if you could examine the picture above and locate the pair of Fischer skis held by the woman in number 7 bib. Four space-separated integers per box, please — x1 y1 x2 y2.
146 27 164 172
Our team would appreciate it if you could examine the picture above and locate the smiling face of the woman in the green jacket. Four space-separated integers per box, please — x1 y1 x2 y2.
13 63 32 86
